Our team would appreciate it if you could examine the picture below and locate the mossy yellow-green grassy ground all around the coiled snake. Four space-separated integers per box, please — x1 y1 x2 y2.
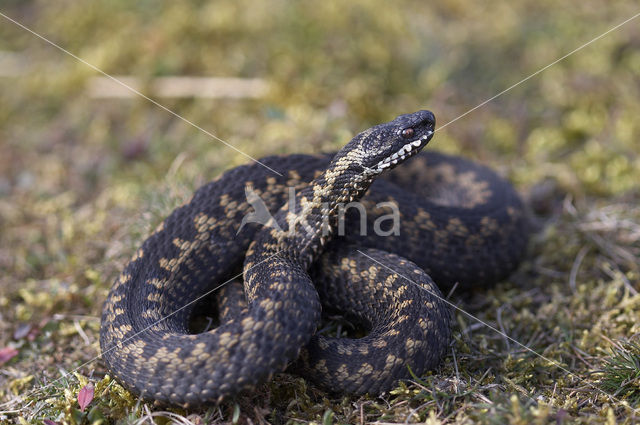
0 0 640 424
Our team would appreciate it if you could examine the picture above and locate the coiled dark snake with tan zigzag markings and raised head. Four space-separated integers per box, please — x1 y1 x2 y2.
100 110 529 407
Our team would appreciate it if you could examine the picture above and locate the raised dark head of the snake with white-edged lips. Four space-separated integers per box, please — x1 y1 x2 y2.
334 110 436 176
